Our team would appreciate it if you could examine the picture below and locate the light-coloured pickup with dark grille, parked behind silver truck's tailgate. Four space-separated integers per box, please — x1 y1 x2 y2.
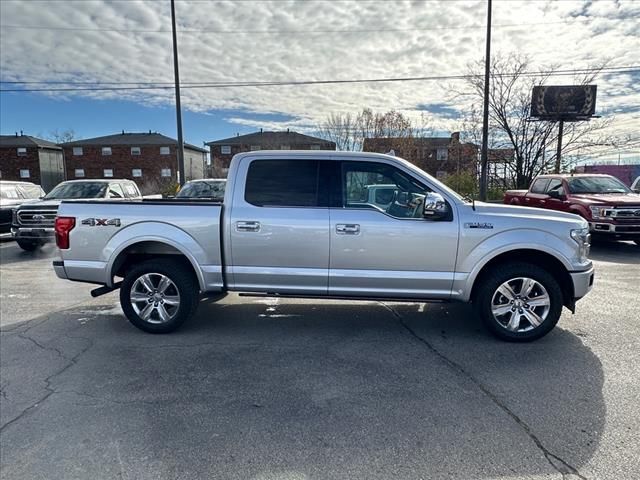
11 179 142 251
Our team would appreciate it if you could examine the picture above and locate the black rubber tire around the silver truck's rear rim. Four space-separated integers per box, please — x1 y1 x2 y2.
120 258 200 333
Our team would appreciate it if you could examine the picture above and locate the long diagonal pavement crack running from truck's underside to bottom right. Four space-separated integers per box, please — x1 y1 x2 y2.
378 302 588 480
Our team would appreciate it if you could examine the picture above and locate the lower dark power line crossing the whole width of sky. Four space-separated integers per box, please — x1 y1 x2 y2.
0 65 640 92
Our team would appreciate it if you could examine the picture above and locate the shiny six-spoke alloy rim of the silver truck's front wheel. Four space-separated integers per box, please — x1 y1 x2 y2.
491 277 551 333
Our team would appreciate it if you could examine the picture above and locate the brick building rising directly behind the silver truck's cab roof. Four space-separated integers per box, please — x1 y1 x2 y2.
207 130 336 177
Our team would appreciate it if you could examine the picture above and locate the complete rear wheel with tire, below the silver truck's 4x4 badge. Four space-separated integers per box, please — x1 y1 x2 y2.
120 258 200 333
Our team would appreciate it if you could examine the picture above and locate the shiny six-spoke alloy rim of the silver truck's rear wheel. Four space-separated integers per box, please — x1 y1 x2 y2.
130 273 180 324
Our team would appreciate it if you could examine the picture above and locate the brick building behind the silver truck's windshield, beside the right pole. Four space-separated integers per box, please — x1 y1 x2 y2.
362 132 479 179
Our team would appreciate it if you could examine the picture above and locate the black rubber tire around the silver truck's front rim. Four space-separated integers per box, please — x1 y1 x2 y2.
473 262 563 342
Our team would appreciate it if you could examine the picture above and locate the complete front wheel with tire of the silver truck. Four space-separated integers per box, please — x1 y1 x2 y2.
474 263 563 342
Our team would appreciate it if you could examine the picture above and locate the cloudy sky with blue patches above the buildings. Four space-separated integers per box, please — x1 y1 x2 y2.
0 0 640 158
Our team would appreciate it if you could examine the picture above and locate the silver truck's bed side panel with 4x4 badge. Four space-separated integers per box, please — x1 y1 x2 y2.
58 199 223 291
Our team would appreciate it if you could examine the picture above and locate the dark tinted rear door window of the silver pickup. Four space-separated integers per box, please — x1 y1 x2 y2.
244 160 327 207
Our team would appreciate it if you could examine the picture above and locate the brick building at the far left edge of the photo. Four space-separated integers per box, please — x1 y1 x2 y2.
0 132 64 192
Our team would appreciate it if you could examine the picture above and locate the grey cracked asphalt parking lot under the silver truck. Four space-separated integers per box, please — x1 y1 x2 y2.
0 241 640 480
